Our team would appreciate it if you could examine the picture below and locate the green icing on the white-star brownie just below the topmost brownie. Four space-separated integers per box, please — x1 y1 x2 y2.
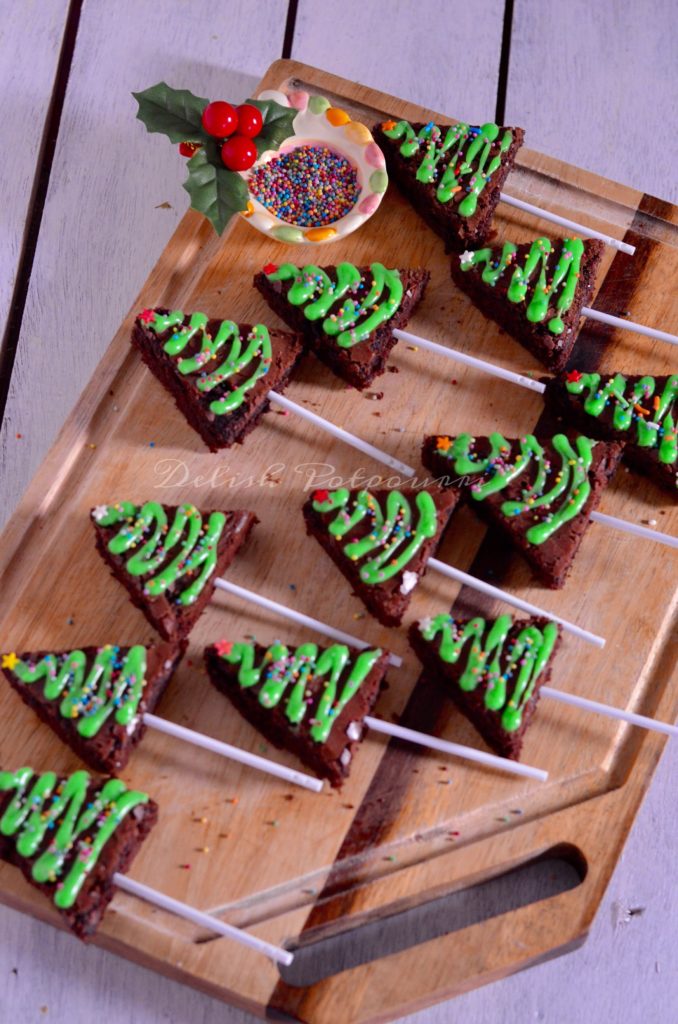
460 239 584 334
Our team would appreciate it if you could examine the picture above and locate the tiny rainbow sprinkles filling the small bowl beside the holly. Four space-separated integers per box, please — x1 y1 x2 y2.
249 145 361 227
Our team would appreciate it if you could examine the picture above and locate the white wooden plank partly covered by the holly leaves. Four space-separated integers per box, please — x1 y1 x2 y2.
0 0 287 525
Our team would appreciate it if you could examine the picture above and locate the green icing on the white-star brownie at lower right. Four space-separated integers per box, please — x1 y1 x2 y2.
419 614 558 732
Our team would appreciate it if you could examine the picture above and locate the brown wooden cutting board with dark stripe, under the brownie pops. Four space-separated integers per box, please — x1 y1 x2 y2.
0 60 678 1024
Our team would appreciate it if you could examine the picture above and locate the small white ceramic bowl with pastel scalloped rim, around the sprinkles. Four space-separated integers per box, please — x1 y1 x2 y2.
242 89 388 245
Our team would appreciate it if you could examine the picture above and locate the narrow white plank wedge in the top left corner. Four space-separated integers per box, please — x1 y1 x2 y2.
0 0 69 344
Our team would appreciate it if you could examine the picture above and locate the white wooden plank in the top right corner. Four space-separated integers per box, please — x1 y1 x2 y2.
506 0 678 203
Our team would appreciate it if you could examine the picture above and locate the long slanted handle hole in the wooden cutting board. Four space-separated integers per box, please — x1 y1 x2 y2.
281 843 587 987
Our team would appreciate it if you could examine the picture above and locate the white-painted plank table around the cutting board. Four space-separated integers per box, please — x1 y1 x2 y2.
0 0 678 1024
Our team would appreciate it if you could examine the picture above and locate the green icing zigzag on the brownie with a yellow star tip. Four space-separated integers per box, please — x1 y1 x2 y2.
12 645 146 739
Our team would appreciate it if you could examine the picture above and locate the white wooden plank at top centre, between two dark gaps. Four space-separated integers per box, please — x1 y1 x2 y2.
292 0 504 124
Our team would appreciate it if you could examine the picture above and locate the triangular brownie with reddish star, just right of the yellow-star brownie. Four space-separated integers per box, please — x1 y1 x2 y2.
205 640 389 786
